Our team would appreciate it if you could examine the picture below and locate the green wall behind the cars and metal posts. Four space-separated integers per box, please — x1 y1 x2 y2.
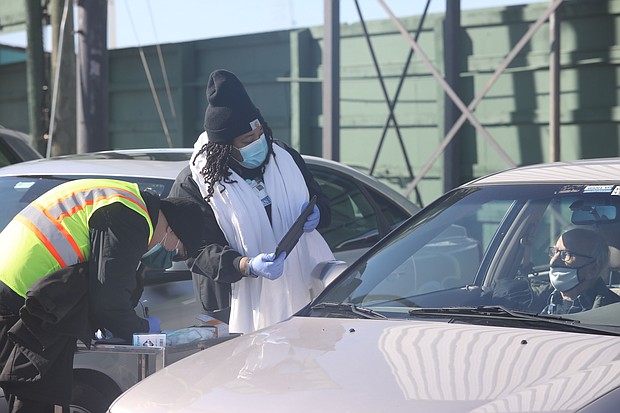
0 0 620 204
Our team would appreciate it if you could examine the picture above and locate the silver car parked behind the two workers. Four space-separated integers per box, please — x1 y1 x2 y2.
0 149 419 413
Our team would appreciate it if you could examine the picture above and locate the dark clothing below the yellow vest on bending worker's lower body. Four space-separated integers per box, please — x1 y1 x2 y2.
0 263 94 405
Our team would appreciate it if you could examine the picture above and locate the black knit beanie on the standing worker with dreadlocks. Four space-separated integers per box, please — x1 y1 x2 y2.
204 69 260 145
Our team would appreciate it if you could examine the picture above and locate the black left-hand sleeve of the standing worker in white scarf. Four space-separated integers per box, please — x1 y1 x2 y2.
170 166 243 286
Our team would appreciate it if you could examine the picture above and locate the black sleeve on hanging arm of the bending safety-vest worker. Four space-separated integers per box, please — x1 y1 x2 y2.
89 202 149 341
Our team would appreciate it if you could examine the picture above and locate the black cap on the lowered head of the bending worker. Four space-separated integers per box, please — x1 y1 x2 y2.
159 197 205 257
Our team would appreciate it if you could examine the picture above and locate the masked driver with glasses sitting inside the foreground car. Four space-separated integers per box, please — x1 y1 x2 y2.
493 228 620 314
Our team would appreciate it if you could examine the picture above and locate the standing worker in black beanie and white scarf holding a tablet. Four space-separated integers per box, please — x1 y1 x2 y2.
171 70 334 333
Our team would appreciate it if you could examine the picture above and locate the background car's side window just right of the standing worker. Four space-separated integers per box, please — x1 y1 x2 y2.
313 170 379 252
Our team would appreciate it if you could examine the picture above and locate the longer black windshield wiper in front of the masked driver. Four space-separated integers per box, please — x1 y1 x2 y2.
409 306 620 336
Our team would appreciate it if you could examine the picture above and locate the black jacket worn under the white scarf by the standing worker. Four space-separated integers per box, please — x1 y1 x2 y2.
170 141 331 322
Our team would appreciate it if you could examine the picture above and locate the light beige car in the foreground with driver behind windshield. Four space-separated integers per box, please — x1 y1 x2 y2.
109 158 620 413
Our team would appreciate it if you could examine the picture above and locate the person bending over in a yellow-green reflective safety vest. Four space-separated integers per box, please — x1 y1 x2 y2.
0 179 204 413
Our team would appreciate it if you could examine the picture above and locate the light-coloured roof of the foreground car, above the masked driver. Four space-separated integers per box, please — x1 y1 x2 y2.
463 158 620 187
